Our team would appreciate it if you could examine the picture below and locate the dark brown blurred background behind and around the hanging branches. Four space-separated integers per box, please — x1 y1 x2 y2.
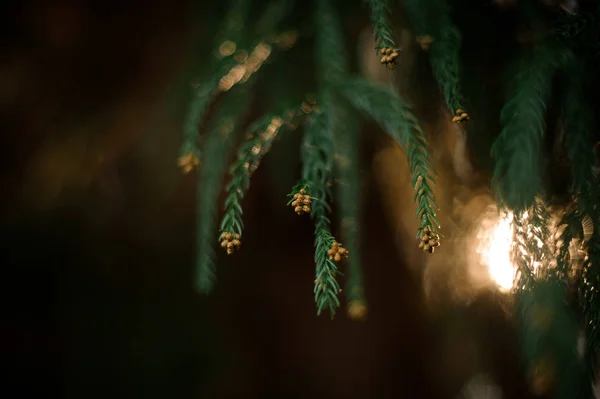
0 0 576 398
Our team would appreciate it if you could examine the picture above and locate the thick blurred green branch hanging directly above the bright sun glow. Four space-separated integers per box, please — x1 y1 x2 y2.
491 43 571 211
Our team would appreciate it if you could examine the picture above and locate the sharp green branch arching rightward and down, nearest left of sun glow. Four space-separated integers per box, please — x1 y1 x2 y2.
342 79 439 237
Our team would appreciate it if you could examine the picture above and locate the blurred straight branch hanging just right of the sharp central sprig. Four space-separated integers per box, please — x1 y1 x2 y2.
329 97 366 316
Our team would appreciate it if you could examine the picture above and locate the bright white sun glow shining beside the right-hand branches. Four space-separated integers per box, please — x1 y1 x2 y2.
477 214 516 291
